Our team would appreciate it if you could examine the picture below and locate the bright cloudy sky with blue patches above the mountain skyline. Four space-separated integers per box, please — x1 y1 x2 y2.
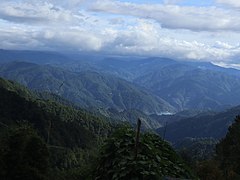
0 0 240 68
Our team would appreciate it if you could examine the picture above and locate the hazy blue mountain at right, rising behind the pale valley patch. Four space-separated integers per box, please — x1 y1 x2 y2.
135 64 240 110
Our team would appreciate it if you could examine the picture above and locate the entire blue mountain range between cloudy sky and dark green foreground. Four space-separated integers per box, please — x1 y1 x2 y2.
0 50 240 135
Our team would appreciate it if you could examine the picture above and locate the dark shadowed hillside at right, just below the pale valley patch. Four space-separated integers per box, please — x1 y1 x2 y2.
157 106 240 142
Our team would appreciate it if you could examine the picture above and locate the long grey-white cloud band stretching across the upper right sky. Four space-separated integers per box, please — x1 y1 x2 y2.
91 0 240 31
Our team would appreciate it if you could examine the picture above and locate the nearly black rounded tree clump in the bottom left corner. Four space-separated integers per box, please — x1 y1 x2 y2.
0 125 50 180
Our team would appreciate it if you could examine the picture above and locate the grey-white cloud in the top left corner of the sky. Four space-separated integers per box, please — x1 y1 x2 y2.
0 1 80 24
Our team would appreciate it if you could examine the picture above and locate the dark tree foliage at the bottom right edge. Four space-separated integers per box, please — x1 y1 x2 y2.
195 116 240 180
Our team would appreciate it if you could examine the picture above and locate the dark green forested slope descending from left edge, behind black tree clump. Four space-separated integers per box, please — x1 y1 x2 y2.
0 78 112 179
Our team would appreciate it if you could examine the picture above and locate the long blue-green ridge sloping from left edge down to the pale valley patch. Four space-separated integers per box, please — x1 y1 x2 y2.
0 62 175 114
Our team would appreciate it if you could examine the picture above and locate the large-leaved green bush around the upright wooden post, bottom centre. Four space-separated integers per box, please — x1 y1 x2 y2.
96 127 193 180
